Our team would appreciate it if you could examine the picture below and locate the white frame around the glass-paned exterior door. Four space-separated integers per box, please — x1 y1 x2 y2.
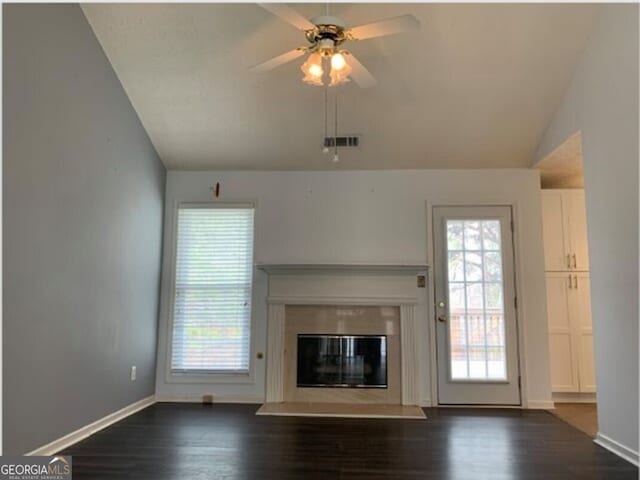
426 201 529 408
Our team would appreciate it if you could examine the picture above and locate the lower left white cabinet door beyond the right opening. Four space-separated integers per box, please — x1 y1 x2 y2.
547 273 580 392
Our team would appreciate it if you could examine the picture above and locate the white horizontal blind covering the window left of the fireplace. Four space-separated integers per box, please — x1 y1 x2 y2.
171 206 253 373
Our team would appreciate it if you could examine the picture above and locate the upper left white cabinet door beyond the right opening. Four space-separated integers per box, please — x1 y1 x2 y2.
541 190 569 272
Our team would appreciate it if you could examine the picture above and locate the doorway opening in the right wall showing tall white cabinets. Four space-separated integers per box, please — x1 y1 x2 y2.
535 132 598 437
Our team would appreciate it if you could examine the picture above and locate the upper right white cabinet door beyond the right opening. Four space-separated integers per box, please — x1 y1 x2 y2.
562 190 589 271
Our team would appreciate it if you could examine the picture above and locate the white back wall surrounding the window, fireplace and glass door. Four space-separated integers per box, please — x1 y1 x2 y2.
157 170 551 406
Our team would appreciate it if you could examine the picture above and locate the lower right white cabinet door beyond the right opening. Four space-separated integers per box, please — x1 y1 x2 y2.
569 273 596 392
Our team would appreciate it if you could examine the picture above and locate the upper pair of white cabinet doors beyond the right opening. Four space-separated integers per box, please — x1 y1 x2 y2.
542 190 589 272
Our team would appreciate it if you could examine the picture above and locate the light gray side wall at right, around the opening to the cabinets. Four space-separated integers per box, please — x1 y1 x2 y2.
537 5 638 454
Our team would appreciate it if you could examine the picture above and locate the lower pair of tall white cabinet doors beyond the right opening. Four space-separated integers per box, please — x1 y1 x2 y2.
547 272 596 392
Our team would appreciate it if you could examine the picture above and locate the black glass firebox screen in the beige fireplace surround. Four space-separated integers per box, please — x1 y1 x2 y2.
297 334 387 388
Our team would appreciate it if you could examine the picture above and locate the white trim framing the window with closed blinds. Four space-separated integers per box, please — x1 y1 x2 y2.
164 200 258 384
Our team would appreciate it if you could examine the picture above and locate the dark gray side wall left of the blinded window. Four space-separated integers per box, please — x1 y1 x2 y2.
3 4 165 454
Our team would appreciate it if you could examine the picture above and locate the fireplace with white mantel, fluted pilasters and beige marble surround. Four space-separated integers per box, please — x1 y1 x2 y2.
260 264 426 406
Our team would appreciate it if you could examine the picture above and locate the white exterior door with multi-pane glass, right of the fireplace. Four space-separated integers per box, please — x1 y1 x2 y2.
433 206 521 405
